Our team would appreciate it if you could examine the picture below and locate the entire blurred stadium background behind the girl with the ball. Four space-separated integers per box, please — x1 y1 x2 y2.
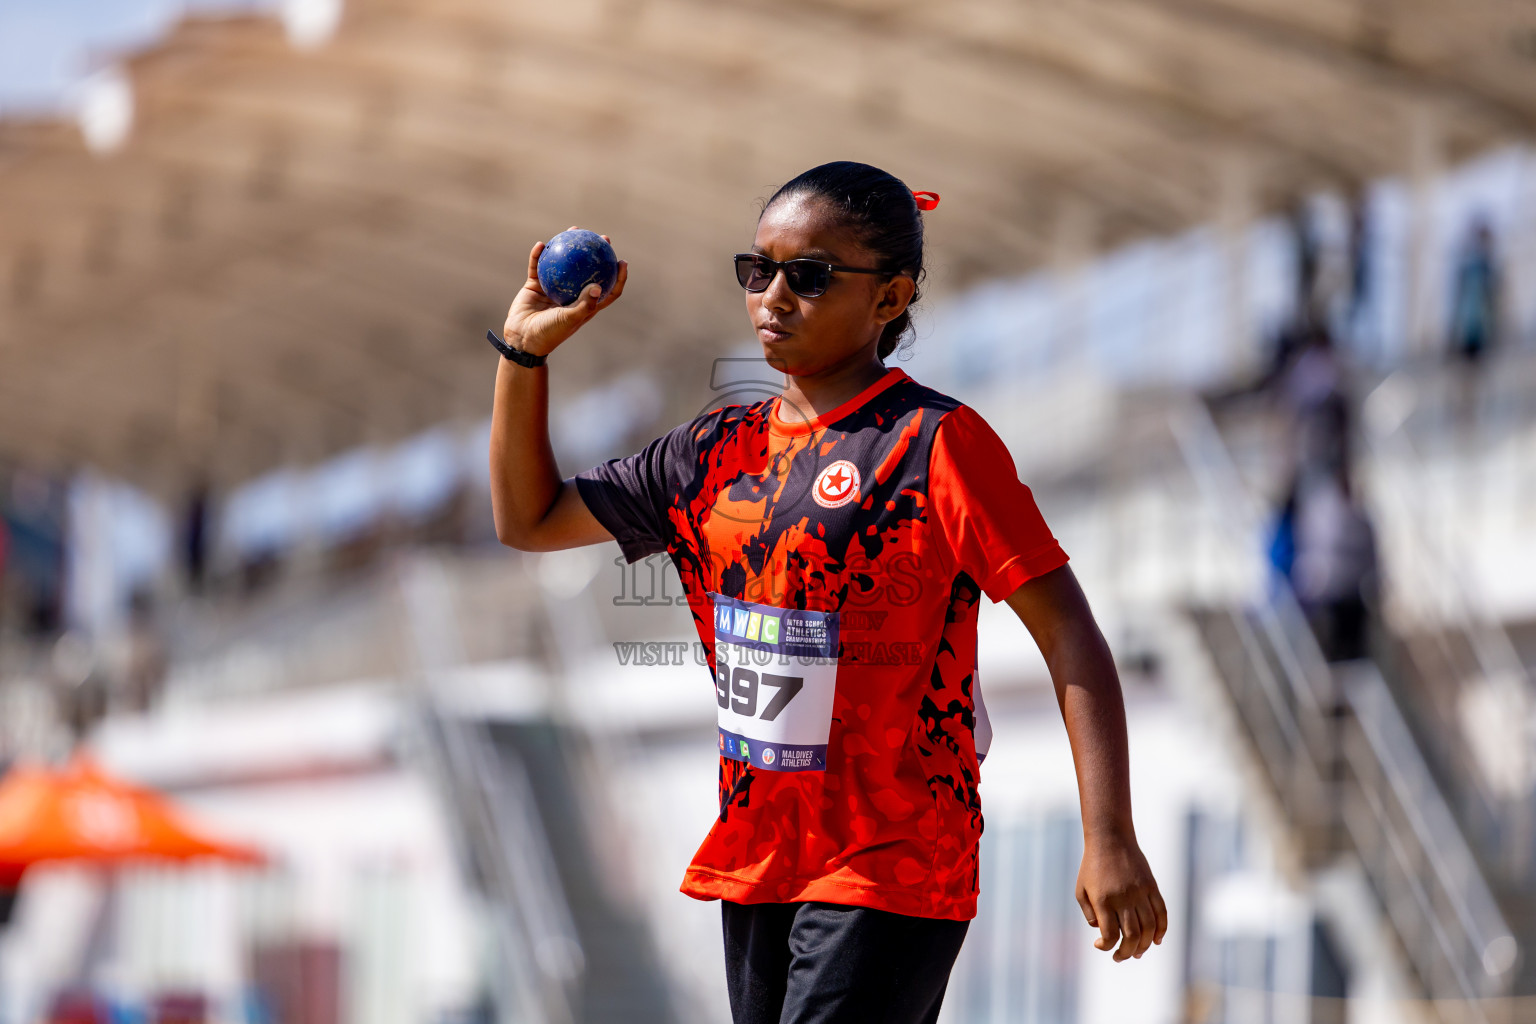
0 0 1536 1024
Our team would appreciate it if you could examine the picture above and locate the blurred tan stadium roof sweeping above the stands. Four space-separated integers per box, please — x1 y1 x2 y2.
0 0 1536 490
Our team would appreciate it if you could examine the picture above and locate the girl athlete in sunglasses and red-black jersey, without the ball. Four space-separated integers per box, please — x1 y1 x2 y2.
490 161 1167 1024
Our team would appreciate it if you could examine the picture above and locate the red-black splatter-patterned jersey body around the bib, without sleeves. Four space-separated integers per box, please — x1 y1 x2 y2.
584 370 1069 920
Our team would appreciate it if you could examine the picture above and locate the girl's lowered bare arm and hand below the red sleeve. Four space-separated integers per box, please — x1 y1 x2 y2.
1008 565 1167 961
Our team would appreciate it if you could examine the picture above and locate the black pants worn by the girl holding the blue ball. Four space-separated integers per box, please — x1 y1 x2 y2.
720 900 971 1024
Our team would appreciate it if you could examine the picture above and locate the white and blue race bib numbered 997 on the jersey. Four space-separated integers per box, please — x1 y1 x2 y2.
710 594 837 772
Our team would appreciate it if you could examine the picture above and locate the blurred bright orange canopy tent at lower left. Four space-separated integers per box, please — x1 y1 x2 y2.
0 757 264 886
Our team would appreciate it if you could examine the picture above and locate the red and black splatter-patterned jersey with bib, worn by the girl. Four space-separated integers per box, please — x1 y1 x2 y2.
576 368 1066 920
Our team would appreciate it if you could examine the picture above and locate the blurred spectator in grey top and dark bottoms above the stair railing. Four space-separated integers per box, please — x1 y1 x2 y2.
1292 465 1378 662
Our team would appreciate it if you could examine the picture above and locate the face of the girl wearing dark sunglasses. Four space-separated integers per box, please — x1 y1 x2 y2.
746 195 917 376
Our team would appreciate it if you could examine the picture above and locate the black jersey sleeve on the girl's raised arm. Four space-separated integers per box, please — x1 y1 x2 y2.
574 424 694 562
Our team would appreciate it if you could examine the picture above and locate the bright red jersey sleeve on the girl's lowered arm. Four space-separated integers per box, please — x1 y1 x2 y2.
928 405 1068 602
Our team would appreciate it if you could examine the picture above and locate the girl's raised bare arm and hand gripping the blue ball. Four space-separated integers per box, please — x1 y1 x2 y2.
490 235 630 551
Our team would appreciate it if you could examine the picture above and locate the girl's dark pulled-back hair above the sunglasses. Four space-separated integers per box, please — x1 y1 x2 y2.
763 160 926 359
